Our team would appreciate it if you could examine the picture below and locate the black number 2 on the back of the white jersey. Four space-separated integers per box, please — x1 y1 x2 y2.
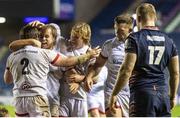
20 58 29 75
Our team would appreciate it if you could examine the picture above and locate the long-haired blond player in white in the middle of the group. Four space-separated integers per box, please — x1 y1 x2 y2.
60 22 91 117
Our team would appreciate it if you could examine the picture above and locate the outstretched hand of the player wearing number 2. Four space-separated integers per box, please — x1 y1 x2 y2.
87 46 101 58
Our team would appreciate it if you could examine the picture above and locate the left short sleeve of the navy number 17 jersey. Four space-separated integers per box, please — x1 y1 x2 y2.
125 34 137 53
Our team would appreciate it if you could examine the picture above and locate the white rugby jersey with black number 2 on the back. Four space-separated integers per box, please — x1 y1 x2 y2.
6 46 60 97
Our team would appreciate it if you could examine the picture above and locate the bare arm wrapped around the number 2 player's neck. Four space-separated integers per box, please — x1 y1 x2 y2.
9 39 41 52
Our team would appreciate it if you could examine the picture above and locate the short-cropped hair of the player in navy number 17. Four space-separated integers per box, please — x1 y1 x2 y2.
136 3 156 22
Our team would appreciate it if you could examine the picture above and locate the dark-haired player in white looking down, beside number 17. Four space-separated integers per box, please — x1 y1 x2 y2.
85 14 133 117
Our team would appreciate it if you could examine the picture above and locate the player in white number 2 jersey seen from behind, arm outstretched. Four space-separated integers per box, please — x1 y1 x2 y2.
4 26 100 117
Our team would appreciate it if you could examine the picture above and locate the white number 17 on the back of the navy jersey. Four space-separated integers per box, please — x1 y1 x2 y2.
148 46 165 65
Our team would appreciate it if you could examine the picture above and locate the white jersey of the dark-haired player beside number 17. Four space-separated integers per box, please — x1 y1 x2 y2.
101 37 129 95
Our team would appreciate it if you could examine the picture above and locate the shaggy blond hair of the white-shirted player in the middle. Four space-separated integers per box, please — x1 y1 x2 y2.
71 22 91 44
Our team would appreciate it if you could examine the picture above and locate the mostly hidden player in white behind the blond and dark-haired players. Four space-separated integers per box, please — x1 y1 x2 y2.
87 66 108 117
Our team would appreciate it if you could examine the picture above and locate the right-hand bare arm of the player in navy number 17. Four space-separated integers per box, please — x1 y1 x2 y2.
168 56 179 108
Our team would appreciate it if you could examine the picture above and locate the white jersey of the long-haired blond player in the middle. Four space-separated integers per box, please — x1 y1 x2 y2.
60 45 89 100
